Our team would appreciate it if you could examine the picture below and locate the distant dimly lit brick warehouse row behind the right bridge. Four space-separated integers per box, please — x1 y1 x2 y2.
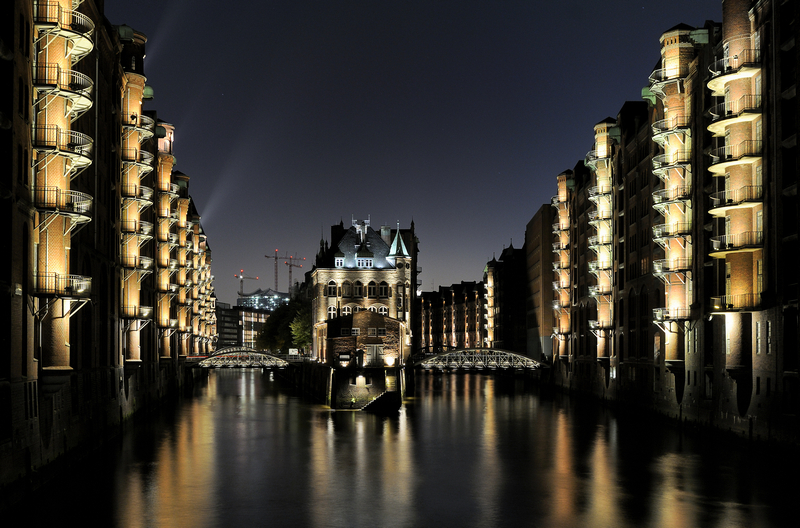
419 281 487 354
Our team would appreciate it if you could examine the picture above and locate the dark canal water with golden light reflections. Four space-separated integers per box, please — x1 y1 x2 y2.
7 369 799 528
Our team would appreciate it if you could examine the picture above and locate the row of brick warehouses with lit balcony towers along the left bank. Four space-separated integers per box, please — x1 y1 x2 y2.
0 0 215 484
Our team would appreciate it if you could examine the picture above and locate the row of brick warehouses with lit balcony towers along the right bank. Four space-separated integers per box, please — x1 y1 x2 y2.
552 0 800 440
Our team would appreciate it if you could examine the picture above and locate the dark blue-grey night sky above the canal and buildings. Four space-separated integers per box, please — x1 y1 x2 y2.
106 0 722 303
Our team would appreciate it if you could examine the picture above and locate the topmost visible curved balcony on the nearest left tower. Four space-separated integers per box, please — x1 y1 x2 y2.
33 2 94 63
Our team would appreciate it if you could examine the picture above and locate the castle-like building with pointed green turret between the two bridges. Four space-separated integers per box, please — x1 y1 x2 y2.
309 220 419 365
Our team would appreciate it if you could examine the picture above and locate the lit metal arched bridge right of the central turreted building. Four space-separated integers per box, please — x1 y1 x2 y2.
412 348 545 370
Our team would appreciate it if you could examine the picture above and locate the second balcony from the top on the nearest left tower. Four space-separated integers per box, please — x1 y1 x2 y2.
33 62 94 121
